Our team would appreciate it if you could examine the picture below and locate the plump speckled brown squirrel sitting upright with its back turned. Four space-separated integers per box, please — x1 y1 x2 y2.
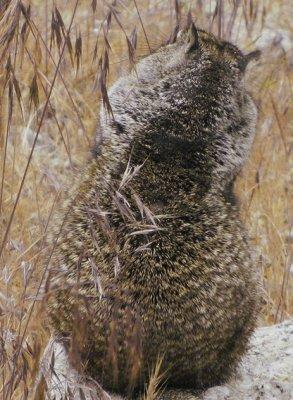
50 25 259 395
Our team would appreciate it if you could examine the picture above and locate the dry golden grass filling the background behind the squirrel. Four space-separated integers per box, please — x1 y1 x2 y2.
0 0 293 400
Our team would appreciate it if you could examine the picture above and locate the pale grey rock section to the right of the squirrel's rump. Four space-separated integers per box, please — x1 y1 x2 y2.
202 320 293 400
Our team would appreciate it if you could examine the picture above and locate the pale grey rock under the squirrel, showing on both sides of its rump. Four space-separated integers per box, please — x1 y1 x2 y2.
37 320 293 400
